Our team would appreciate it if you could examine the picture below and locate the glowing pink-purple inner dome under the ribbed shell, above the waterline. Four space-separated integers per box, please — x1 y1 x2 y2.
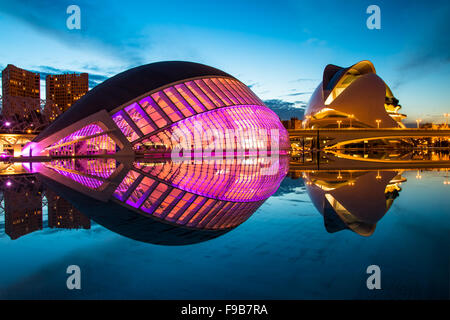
136 105 290 156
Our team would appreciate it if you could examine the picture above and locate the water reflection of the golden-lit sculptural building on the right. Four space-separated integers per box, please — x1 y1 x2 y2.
303 171 406 236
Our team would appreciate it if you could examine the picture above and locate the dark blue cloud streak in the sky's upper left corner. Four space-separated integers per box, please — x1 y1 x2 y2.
0 0 149 66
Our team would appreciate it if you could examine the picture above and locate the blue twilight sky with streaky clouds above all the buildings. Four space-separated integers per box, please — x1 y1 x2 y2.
0 0 450 122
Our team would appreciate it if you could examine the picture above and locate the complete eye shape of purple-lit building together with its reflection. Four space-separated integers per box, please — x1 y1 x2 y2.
22 62 290 244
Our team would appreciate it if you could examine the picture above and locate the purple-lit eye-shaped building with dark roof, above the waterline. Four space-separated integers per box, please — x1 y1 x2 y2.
22 61 290 156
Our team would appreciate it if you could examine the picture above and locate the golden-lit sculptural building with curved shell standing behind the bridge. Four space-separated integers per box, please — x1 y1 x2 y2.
305 60 406 128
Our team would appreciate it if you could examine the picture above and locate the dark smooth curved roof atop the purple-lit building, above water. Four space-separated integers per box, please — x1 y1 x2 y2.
34 61 234 142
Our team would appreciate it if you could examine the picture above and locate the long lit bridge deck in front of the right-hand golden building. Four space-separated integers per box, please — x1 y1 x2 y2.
288 128 450 149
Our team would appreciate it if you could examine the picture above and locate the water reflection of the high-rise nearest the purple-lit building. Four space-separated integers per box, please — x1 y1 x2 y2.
46 190 91 229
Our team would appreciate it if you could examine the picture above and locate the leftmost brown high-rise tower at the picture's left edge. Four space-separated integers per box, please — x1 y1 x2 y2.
2 64 41 124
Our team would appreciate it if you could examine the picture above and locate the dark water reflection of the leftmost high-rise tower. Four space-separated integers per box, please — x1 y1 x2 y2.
3 179 42 240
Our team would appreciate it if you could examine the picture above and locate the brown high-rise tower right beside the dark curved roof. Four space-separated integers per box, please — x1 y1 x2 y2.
45 73 89 121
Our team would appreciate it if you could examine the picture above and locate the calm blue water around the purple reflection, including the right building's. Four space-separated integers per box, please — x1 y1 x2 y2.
0 162 450 299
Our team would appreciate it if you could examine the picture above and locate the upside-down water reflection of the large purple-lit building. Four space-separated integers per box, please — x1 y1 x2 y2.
20 156 289 245
